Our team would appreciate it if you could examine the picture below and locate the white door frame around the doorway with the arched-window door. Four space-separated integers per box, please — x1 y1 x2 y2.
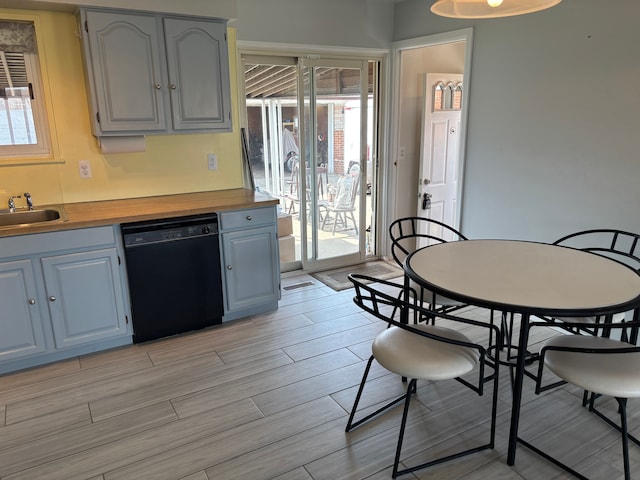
380 27 473 256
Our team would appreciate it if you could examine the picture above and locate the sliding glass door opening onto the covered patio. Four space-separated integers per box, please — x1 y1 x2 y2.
243 55 378 271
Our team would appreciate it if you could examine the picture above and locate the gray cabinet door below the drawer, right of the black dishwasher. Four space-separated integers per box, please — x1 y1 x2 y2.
222 227 280 313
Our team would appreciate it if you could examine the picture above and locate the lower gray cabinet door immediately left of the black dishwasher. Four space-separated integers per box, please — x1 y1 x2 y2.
41 248 128 349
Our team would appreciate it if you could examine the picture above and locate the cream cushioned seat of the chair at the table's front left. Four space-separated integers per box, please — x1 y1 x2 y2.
372 324 479 380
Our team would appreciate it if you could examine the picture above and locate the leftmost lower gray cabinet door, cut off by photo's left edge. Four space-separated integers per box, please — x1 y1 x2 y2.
0 260 46 362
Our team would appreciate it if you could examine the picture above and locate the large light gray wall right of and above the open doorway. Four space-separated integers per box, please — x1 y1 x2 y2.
394 0 640 241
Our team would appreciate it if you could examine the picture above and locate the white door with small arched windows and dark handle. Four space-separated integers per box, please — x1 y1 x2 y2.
417 73 463 247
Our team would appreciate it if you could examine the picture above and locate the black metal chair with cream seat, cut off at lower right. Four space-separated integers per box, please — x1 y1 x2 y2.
518 313 640 480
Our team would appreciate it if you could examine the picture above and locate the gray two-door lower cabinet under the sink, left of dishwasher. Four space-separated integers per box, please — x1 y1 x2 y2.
0 226 131 373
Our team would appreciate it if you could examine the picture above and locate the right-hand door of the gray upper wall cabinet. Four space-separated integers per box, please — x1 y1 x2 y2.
164 18 231 131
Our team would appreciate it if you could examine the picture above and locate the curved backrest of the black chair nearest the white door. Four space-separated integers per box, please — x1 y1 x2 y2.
389 217 467 266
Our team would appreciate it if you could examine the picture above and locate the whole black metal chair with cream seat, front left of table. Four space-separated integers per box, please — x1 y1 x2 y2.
346 274 499 478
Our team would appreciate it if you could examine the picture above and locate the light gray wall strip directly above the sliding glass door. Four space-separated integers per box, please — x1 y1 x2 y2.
234 0 393 49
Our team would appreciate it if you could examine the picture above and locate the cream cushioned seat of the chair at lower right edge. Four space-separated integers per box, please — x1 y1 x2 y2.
544 335 640 398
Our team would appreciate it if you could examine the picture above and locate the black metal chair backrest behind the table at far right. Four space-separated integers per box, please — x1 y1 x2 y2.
553 229 640 273
